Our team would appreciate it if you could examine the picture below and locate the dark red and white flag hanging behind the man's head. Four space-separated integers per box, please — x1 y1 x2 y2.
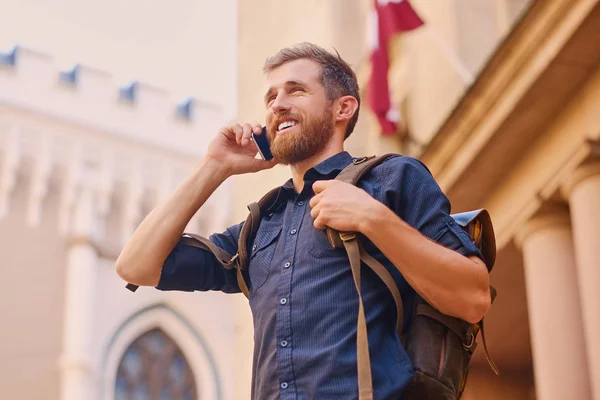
368 0 423 135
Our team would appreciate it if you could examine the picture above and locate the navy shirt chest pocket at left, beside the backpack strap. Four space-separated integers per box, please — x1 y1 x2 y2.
248 225 281 293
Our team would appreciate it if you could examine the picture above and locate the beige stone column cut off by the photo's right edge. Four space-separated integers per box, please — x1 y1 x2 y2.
567 160 600 400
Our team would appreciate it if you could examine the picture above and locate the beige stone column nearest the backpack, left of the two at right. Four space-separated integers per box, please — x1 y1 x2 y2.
518 208 591 400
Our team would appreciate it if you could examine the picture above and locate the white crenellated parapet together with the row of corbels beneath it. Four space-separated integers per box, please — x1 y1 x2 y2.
0 48 230 253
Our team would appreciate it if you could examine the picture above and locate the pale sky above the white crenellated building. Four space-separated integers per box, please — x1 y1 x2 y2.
0 0 237 113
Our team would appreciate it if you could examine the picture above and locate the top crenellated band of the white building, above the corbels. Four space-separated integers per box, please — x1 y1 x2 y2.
0 47 226 155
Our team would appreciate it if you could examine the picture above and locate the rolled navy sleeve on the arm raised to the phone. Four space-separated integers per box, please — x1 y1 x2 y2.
156 223 243 293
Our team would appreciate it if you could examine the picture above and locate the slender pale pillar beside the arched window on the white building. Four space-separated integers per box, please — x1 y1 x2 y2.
60 184 98 400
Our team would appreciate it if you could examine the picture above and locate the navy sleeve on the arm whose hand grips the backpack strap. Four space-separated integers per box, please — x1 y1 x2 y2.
379 157 483 259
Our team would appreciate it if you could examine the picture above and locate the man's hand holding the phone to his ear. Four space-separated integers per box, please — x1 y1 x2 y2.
206 122 277 175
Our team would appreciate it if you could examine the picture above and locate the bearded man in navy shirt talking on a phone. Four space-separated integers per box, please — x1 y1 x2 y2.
116 43 490 400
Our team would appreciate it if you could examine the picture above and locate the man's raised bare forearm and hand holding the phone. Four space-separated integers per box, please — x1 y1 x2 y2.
116 123 277 286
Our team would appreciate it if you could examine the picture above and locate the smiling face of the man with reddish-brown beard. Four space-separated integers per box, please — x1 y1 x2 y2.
265 59 334 165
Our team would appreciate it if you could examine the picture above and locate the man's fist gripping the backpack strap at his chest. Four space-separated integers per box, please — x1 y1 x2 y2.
310 179 381 232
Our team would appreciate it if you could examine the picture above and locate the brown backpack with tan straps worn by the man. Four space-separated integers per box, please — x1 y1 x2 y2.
127 154 499 400
